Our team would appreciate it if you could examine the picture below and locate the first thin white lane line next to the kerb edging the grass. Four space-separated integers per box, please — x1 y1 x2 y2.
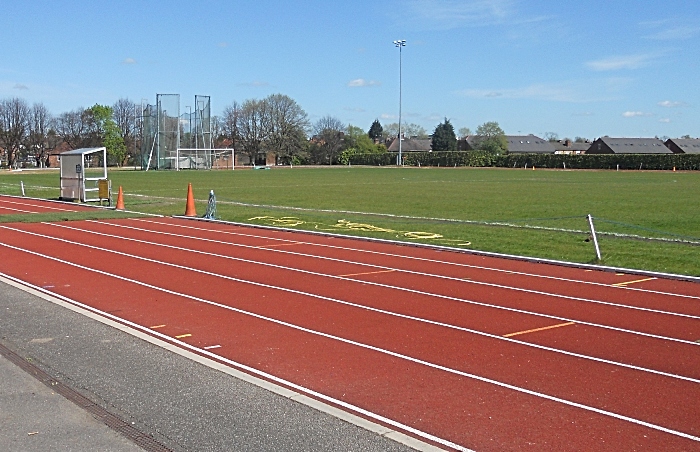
132 218 700 300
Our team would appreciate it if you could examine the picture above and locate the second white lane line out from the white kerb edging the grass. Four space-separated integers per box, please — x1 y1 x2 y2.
90 220 700 320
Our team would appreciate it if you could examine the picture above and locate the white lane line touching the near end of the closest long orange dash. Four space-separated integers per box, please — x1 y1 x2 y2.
5 222 700 383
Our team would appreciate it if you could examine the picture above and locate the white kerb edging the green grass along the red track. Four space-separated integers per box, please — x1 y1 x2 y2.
178 215 700 283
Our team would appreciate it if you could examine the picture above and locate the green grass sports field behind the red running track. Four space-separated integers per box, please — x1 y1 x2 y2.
0 167 700 276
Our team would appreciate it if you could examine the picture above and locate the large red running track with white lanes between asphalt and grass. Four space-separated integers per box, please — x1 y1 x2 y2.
0 211 700 450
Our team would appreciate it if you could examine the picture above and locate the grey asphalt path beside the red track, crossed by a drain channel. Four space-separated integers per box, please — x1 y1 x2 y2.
0 282 424 451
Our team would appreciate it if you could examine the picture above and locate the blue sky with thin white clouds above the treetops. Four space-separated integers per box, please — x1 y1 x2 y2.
0 0 700 139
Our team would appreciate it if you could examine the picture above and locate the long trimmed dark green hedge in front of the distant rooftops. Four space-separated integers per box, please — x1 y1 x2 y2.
349 151 700 171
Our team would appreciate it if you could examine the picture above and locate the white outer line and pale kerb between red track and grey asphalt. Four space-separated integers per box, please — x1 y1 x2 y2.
0 272 456 452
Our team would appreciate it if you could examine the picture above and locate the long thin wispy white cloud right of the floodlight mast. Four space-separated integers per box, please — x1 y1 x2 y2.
458 78 629 102
